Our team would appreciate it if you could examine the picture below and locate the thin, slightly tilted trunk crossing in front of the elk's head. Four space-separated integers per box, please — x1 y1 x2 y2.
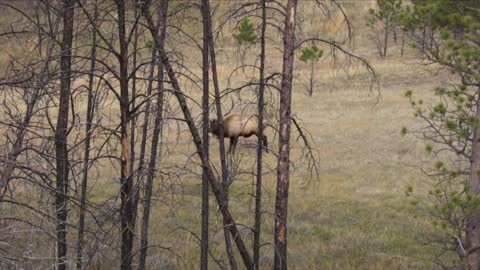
202 0 237 270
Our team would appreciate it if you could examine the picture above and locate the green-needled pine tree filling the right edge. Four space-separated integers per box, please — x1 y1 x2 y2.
401 0 480 269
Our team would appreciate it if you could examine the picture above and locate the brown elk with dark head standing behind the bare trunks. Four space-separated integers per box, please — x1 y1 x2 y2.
208 114 268 153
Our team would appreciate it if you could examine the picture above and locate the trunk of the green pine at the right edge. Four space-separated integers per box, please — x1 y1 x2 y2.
466 98 480 270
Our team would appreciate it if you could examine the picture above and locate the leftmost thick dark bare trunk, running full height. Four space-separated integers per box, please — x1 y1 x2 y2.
55 0 75 270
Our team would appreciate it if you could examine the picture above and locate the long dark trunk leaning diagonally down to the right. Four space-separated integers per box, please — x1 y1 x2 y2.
143 0 253 269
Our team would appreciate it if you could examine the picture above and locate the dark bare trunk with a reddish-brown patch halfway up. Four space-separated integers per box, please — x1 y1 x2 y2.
115 0 135 270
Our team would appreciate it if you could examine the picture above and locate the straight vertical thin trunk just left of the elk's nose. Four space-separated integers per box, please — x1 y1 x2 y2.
200 0 210 270
